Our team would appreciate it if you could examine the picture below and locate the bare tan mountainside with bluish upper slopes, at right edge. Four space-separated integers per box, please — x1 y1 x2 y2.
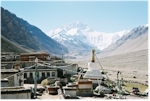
102 25 148 55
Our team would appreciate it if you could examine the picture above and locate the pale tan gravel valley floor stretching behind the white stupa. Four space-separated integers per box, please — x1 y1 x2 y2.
67 50 148 90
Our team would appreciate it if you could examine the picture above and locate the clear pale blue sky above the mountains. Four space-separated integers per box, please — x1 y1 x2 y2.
1 1 148 33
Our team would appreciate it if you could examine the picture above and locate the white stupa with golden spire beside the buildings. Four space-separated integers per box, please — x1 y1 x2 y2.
83 50 103 80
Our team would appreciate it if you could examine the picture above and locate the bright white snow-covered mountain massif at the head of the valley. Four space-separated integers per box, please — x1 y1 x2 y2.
47 21 129 51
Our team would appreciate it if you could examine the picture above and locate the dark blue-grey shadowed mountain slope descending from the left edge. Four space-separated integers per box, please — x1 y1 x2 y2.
1 7 68 55
